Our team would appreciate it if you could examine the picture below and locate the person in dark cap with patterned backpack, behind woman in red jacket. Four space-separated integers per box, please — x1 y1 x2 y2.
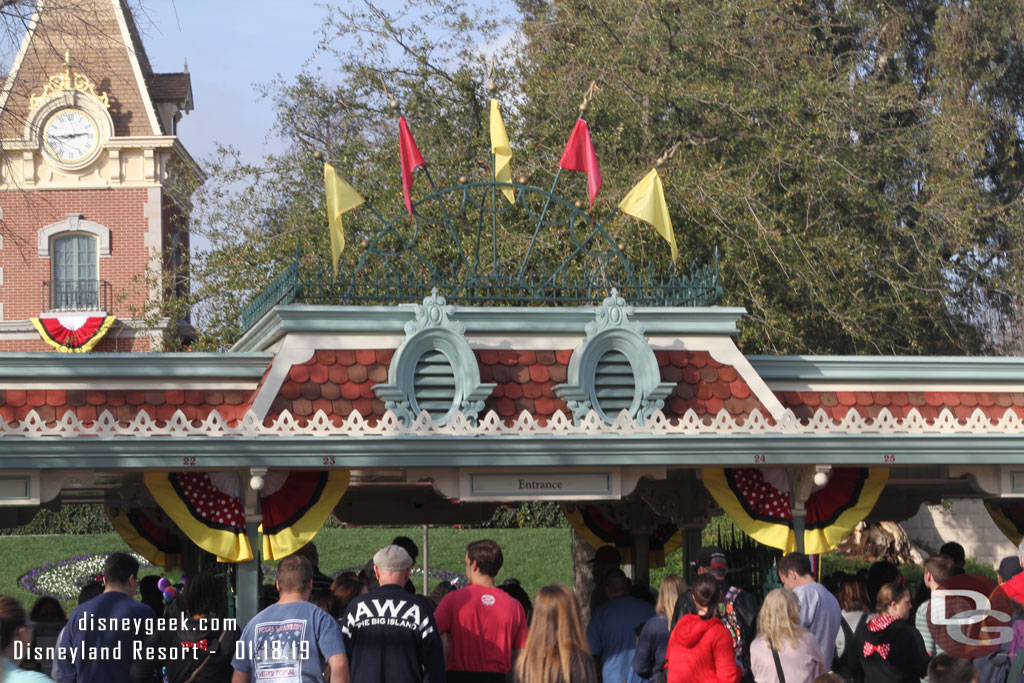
672 546 759 683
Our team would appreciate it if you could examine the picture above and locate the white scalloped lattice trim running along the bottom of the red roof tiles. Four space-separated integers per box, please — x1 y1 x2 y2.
0 409 1024 438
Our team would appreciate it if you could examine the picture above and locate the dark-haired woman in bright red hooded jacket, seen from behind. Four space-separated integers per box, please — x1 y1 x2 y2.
665 573 742 683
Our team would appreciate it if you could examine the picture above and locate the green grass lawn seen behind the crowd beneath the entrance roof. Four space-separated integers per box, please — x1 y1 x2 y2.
0 527 572 607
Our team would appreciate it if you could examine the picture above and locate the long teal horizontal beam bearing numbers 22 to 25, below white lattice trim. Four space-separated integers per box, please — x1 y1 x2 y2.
6 433 1024 470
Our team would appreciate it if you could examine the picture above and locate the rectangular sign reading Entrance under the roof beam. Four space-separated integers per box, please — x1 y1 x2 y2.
460 468 622 501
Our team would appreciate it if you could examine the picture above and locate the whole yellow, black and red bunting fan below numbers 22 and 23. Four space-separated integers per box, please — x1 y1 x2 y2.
145 470 349 562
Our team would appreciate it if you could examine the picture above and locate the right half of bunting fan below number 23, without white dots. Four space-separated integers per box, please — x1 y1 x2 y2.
260 470 348 560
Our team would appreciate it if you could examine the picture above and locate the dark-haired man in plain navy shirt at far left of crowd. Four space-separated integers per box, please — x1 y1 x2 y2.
54 552 157 683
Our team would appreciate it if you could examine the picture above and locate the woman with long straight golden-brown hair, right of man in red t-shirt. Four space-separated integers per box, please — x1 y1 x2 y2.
513 584 597 683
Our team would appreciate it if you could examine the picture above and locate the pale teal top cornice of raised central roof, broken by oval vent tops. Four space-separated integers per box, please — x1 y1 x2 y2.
231 304 746 352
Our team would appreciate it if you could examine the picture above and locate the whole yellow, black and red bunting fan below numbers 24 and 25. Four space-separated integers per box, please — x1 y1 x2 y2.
701 467 889 555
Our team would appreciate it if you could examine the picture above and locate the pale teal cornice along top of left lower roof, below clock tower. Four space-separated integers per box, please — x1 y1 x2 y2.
0 353 273 383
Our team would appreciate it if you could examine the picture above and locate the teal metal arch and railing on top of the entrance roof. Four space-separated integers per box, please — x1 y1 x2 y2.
242 181 723 329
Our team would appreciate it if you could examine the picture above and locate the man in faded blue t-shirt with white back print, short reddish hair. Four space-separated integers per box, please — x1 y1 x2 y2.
231 555 349 683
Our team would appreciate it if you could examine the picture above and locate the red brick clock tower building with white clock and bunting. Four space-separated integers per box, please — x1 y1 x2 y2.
0 0 197 352
